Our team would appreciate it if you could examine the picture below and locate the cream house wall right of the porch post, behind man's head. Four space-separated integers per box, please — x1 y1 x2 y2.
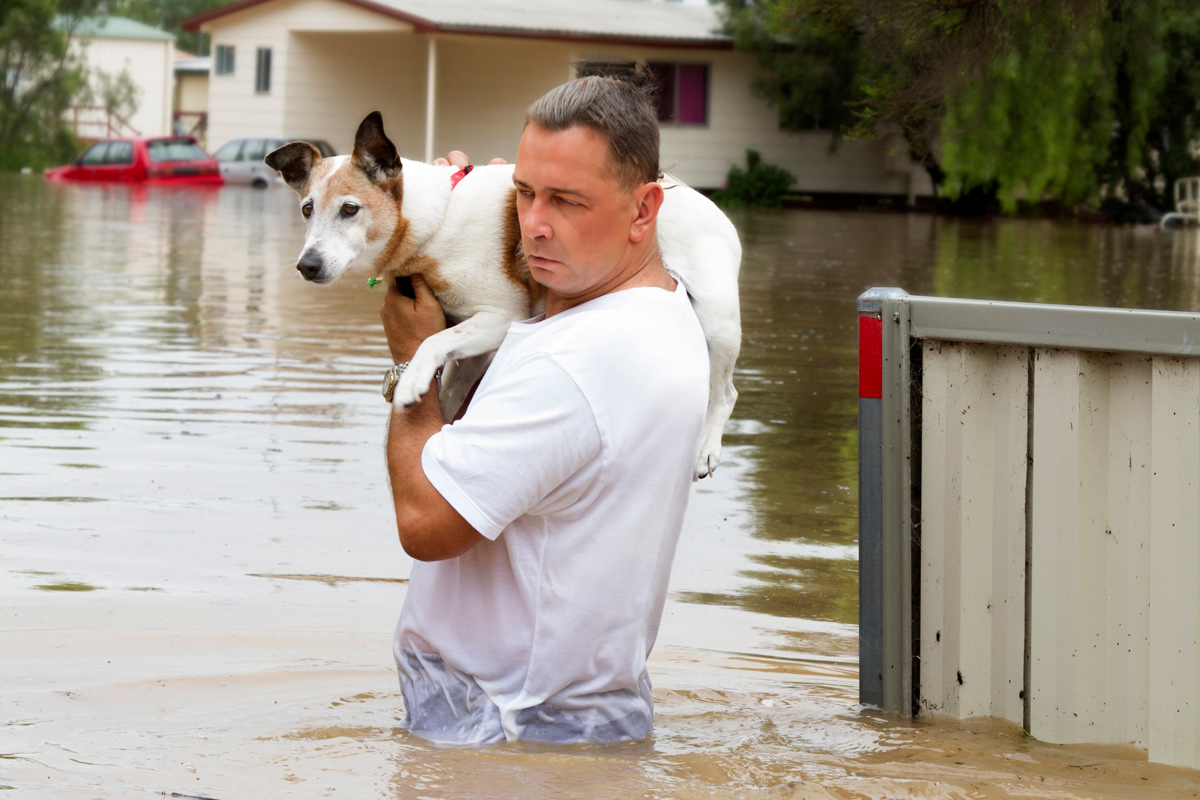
421 36 932 196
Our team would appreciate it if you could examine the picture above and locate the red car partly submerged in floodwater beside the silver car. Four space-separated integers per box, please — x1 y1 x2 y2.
46 136 224 186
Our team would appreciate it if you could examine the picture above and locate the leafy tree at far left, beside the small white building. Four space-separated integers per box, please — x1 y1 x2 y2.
0 0 101 169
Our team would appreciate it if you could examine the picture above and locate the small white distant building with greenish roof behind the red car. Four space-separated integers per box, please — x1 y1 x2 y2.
70 17 175 139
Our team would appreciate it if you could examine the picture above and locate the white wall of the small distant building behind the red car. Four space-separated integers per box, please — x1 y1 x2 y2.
72 37 174 138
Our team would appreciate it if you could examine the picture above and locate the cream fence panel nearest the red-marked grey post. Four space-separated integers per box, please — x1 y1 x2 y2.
920 342 1028 724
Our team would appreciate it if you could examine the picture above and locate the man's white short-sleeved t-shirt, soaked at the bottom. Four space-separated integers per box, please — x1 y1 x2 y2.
395 284 708 744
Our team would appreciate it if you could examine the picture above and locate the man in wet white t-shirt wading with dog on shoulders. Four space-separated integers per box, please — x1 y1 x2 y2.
380 67 708 744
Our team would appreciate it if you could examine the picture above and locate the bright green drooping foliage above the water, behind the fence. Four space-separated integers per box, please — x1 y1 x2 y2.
941 0 1176 212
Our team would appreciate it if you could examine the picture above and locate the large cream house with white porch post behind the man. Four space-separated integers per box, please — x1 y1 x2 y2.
184 0 932 199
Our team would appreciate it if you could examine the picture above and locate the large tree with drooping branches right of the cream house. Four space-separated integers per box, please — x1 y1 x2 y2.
722 0 1200 211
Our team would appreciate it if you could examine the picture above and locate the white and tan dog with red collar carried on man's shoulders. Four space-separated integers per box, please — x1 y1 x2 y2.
264 112 742 480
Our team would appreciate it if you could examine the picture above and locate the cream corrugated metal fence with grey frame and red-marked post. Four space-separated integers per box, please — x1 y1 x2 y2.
859 289 1200 766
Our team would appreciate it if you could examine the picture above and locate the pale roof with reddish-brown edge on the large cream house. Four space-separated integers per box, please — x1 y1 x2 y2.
184 0 730 48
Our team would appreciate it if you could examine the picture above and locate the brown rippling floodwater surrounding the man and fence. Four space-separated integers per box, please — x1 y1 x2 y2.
0 175 1200 800
